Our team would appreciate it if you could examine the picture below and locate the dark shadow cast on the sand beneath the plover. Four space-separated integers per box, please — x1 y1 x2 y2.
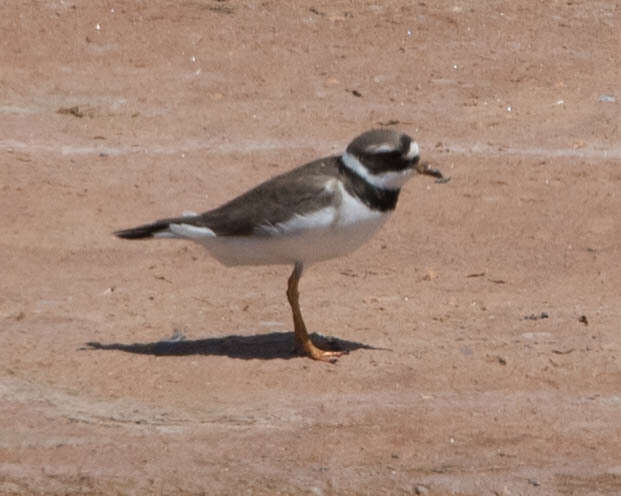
81 332 391 360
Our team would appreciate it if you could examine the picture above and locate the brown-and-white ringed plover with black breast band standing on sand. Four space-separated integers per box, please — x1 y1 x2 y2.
115 129 443 361
